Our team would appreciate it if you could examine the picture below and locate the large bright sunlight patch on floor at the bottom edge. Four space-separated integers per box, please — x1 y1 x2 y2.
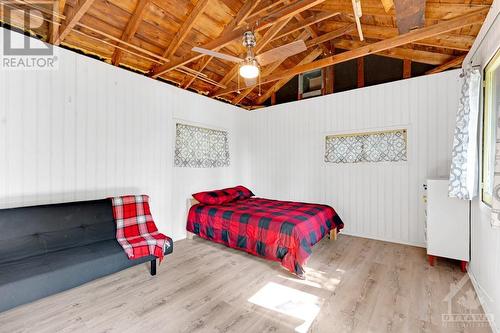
248 282 323 333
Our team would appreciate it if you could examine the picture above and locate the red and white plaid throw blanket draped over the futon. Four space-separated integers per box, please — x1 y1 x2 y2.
111 195 172 262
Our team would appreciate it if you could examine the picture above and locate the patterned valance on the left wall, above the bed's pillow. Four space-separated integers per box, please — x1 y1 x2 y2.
174 124 229 168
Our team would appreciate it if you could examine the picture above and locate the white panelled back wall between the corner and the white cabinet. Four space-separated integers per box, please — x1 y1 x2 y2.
250 71 459 246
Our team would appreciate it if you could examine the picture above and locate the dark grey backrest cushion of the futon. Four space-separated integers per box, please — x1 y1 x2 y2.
0 199 116 264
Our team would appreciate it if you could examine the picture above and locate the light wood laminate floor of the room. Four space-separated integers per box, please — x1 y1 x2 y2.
0 235 490 333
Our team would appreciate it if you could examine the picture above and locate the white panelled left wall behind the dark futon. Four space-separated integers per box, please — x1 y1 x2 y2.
0 29 248 239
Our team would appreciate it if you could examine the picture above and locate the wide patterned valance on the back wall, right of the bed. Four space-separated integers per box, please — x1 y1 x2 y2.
325 129 407 163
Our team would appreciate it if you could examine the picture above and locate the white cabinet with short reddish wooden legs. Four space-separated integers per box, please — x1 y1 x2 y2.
425 179 470 271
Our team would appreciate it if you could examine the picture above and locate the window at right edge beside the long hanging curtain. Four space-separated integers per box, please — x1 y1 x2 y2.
481 51 500 206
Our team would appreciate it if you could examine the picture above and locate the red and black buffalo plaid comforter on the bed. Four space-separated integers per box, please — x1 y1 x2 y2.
186 198 344 275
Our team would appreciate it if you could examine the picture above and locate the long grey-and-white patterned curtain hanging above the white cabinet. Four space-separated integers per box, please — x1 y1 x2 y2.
448 69 481 200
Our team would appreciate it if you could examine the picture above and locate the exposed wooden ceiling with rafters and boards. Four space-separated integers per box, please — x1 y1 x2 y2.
0 0 492 107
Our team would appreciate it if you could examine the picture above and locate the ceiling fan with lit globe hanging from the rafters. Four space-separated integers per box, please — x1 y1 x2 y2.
192 31 307 86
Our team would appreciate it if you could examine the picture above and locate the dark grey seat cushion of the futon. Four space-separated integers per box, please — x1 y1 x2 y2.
0 240 155 312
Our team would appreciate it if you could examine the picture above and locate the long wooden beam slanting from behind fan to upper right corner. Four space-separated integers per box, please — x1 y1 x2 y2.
216 8 489 96
